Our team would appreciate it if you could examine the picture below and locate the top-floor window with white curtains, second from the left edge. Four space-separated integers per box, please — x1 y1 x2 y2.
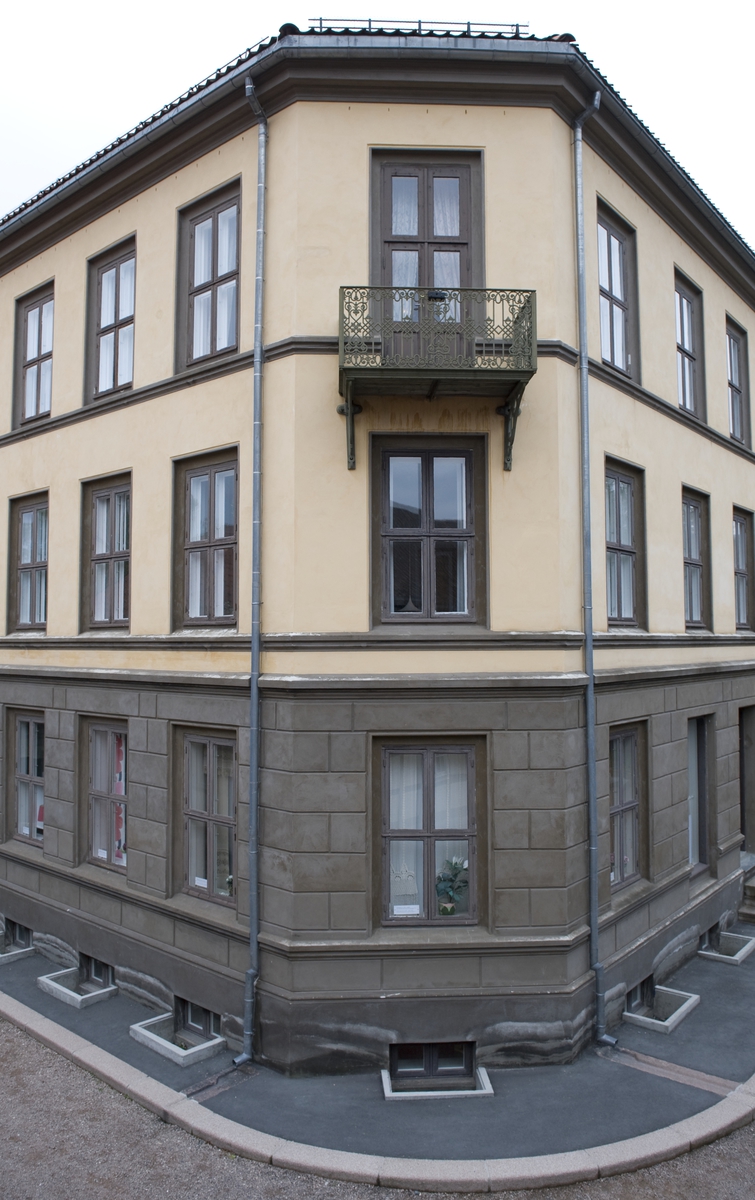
94 246 137 396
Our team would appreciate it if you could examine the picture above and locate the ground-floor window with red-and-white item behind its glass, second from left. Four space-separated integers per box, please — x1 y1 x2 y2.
89 726 127 871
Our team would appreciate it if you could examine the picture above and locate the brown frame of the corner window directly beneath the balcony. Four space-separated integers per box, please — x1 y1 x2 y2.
372 436 487 629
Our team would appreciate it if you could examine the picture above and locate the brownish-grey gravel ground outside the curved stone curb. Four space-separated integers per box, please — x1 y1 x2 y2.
0 1021 755 1200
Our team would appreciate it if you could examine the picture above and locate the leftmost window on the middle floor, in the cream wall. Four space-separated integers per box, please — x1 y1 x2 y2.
8 496 48 630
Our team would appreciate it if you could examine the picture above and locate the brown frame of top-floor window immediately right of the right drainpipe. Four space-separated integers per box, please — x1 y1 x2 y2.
597 203 640 383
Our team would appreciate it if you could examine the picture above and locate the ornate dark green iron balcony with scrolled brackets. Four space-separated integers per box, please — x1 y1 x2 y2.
338 287 538 470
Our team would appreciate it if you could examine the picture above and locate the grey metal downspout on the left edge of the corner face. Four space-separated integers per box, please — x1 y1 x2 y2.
234 76 268 1067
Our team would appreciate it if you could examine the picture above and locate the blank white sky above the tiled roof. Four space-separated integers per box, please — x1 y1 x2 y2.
0 0 755 246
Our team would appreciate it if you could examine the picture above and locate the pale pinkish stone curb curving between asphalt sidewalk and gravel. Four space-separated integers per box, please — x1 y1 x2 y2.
0 991 755 1192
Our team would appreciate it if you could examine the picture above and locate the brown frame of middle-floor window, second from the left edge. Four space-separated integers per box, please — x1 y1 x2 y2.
80 473 132 630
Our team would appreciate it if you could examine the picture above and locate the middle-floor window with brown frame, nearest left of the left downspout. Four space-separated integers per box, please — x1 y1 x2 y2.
174 451 238 628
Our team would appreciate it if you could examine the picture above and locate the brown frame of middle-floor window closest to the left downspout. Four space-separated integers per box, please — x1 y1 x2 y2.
173 448 239 629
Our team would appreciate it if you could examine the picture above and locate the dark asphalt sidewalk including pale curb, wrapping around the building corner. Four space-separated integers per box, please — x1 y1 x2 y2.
0 926 755 1190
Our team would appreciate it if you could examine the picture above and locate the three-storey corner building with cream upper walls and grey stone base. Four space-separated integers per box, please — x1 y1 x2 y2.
0 26 755 1072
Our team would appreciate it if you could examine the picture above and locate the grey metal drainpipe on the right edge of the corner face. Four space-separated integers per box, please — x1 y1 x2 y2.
573 91 616 1045
